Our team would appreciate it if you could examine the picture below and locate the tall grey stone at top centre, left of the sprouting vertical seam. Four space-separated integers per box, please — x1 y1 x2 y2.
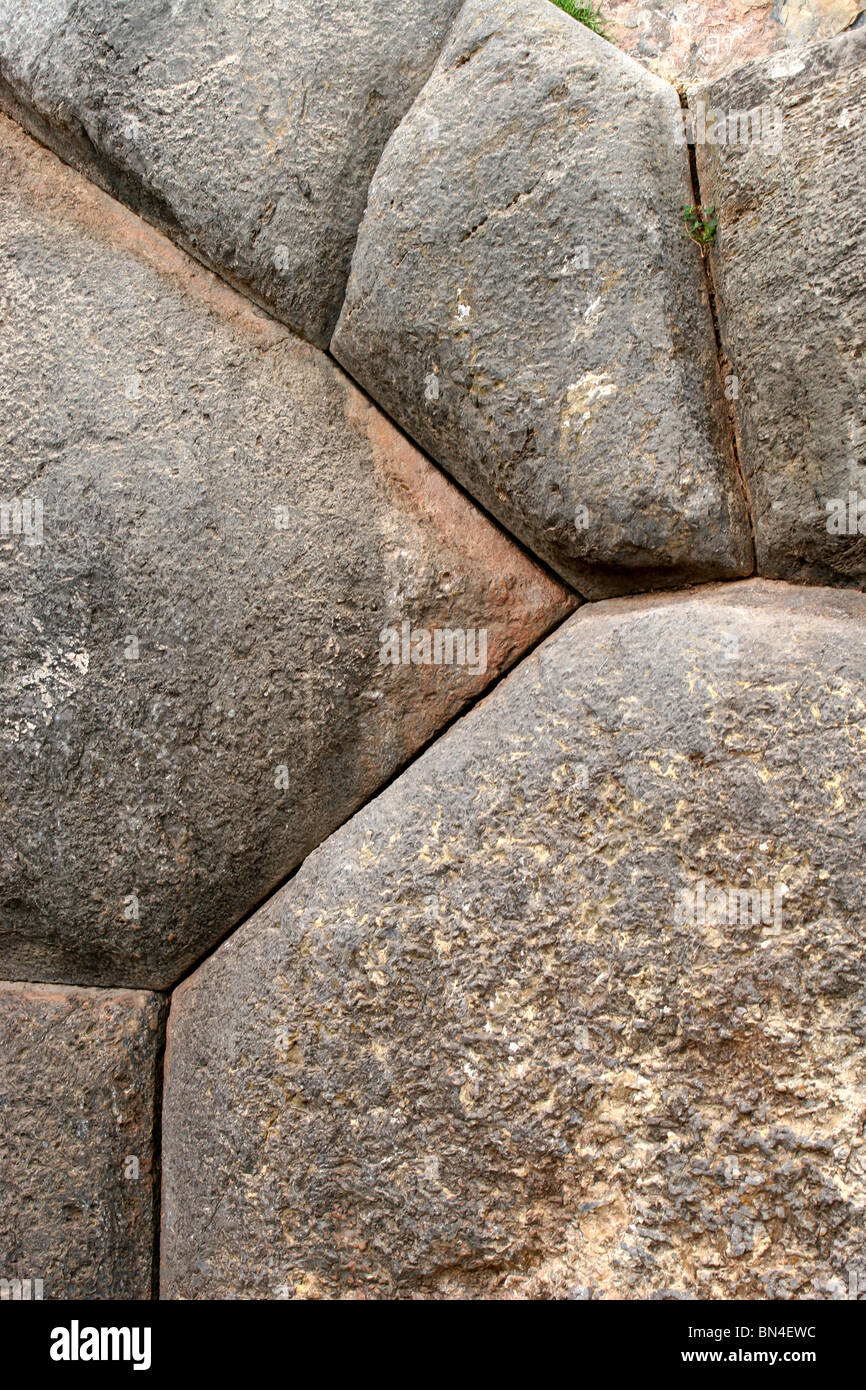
332 0 752 598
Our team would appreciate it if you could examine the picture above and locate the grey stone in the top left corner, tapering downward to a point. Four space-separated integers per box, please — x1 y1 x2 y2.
0 0 459 348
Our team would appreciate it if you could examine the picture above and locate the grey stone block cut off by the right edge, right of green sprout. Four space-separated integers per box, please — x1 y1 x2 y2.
689 28 866 588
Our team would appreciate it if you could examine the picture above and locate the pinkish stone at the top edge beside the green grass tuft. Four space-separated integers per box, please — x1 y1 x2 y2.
602 0 863 83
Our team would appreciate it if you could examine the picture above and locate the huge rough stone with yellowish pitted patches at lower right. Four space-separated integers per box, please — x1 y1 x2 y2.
161 581 866 1298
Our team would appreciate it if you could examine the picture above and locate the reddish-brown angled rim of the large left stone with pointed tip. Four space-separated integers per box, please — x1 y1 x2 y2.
0 115 578 990
